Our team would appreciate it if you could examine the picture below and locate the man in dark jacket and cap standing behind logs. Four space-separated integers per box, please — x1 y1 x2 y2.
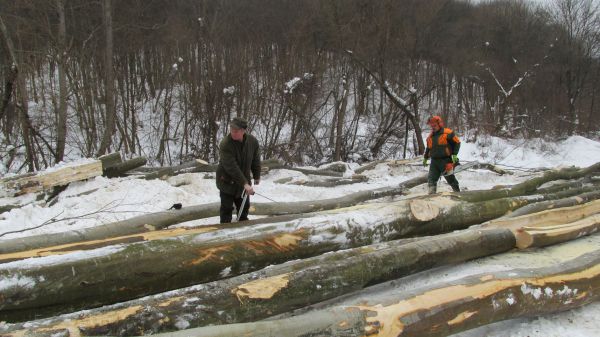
216 117 260 223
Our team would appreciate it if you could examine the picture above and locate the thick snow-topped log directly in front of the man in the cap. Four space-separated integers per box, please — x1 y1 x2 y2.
0 195 544 321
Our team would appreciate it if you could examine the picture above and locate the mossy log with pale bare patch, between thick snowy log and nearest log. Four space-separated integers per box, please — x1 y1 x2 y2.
1 229 515 337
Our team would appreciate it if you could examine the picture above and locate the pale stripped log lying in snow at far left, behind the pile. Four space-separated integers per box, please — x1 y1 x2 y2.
0 160 102 196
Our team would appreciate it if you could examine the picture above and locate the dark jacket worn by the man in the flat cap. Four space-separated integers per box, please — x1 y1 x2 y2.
216 134 260 197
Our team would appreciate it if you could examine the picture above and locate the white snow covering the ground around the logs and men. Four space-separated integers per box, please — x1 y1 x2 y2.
0 136 600 337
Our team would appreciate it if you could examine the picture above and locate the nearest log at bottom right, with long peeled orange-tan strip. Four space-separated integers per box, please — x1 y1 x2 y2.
154 244 600 337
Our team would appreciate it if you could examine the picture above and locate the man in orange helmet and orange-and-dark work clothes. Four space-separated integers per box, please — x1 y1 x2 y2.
423 116 460 194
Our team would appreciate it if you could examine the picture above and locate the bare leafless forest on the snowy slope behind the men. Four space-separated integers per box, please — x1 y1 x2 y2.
0 0 600 173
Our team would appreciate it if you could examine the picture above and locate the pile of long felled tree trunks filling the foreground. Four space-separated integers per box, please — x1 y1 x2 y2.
0 163 600 336
